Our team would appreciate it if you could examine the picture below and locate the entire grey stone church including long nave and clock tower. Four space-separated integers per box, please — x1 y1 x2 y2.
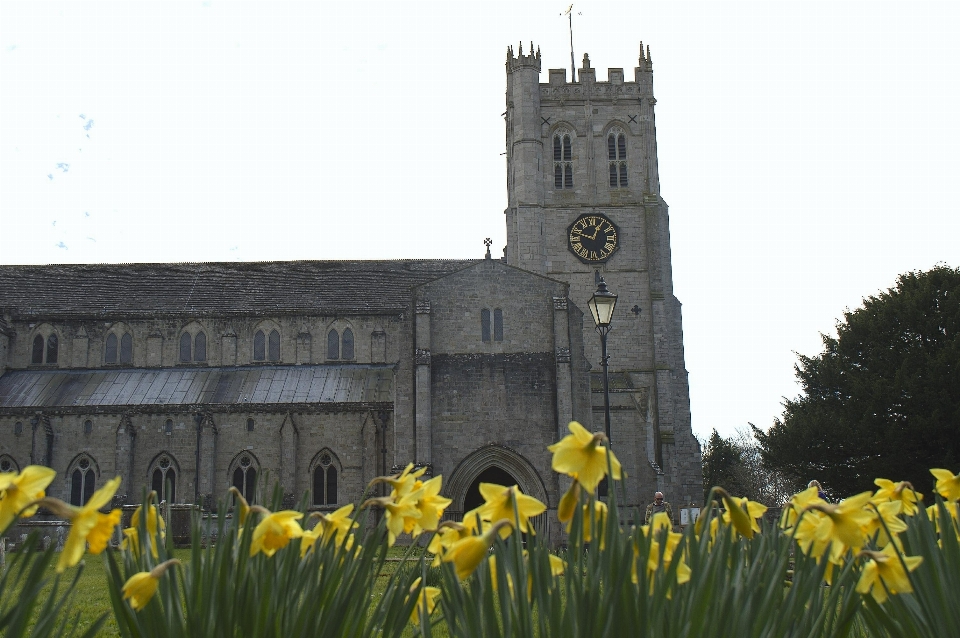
0 45 703 541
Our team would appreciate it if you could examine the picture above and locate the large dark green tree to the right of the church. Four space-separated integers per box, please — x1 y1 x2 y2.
754 266 960 496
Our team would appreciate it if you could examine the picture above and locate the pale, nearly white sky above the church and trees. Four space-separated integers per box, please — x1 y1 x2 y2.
0 0 960 444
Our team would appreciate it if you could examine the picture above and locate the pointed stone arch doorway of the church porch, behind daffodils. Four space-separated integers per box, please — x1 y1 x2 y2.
444 445 556 533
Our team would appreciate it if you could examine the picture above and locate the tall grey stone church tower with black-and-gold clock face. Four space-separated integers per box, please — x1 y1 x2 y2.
504 44 703 511
